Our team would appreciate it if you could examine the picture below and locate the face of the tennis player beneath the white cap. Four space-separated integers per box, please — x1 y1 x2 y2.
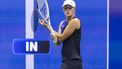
63 5 75 16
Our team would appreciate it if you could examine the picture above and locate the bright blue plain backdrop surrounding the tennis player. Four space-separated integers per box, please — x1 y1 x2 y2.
0 0 107 69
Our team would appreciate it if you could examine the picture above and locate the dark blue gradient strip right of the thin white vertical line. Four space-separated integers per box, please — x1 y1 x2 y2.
109 0 122 69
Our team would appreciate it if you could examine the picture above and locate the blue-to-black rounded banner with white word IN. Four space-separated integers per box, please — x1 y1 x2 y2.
13 39 50 54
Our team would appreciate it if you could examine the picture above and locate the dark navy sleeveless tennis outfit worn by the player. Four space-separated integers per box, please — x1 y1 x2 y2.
60 17 82 69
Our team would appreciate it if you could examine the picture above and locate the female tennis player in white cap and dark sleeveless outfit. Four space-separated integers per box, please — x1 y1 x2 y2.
40 0 82 69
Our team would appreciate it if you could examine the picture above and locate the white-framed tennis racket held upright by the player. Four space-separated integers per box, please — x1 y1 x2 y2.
36 0 57 43
